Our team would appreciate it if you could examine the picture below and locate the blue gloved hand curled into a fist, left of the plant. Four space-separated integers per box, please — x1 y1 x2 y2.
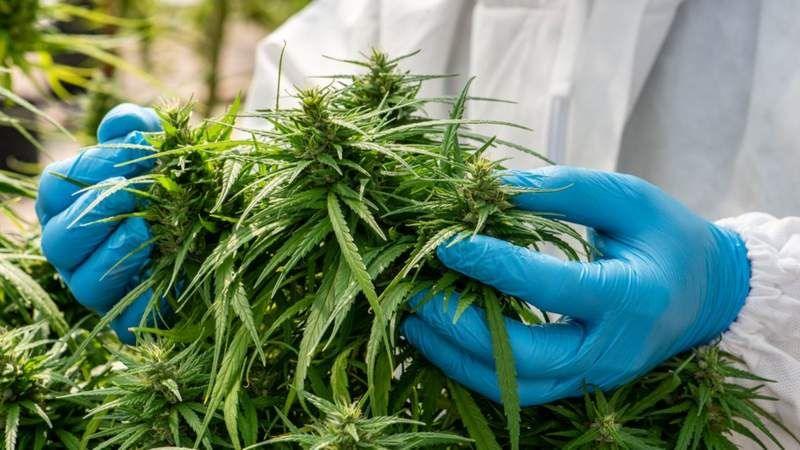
36 103 161 343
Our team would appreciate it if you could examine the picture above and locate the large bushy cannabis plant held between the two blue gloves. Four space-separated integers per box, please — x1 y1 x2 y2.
62 52 792 449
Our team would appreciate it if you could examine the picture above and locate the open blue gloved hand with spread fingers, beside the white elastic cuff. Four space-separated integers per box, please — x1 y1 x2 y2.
402 167 750 405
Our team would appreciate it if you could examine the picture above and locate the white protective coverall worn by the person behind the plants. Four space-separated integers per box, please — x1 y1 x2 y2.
247 0 800 449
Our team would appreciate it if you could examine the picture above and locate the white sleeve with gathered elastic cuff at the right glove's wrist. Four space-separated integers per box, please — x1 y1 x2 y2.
717 213 800 442
